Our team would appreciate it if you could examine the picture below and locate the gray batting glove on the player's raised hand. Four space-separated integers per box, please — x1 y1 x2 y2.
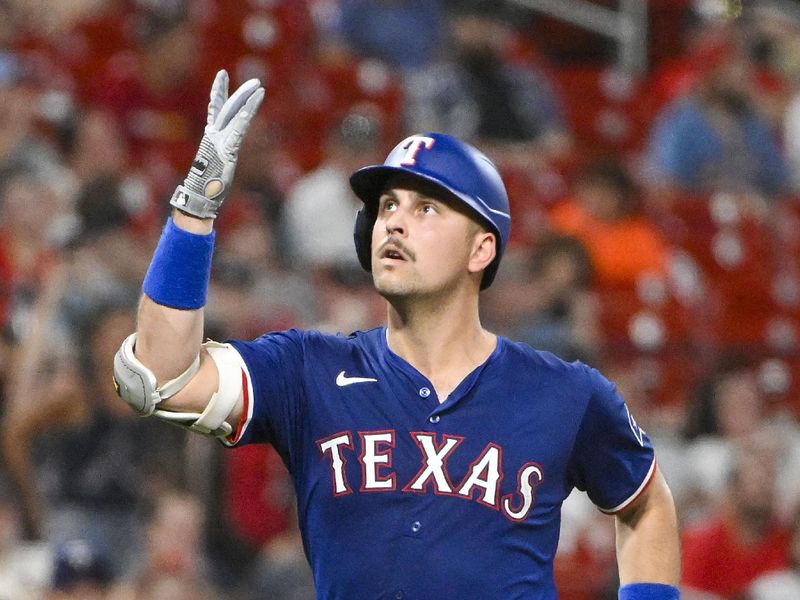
169 70 264 219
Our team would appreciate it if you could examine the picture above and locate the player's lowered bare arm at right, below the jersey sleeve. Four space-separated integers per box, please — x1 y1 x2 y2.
616 470 680 600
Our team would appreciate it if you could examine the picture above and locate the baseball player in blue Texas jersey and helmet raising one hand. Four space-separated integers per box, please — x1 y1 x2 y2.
114 71 679 600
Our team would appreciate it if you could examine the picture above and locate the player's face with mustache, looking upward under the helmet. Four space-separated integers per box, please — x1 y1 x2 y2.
372 178 494 298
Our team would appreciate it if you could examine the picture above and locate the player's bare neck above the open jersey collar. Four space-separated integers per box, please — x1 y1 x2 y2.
387 288 497 398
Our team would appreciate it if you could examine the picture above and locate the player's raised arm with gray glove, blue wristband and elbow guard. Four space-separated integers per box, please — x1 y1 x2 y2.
114 71 264 438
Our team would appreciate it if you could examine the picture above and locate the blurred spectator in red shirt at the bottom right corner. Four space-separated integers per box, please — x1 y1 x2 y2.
683 447 790 599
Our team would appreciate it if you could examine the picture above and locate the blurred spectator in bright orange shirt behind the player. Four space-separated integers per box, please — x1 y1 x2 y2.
550 160 668 287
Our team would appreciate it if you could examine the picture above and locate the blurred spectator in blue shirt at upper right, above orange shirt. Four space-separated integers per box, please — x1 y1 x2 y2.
647 29 787 203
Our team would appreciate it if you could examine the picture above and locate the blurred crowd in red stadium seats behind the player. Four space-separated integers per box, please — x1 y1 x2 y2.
0 0 800 600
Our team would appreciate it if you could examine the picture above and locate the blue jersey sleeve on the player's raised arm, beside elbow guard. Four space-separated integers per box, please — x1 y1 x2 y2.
225 329 304 452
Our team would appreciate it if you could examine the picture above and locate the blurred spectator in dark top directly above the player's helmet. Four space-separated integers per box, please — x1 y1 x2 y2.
406 0 571 169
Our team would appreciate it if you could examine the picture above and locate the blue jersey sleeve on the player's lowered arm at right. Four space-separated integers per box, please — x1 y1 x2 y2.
570 369 655 513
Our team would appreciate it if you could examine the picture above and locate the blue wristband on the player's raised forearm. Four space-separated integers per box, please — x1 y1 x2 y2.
142 218 216 310
